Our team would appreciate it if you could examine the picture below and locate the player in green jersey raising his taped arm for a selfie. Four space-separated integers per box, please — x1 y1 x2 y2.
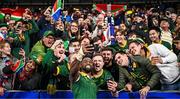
69 47 97 99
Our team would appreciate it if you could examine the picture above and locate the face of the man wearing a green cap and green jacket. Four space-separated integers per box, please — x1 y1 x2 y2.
43 35 55 48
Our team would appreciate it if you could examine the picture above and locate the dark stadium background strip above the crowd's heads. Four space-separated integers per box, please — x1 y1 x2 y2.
0 0 180 13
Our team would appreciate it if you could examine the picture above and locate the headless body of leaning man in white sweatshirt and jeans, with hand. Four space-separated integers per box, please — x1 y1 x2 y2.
148 44 180 90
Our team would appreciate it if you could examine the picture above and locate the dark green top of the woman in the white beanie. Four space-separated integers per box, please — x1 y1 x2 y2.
41 49 70 90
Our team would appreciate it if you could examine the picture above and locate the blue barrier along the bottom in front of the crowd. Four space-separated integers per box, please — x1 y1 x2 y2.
0 90 180 99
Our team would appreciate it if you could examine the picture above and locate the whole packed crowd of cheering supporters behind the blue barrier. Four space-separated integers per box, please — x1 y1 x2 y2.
0 4 180 98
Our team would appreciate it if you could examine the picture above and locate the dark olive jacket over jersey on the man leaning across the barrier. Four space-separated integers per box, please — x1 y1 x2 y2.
118 55 161 90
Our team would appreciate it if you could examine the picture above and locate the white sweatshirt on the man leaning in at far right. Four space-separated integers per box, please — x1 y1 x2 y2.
148 44 180 84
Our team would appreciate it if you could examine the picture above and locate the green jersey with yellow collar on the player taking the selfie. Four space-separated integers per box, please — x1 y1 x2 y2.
72 72 97 99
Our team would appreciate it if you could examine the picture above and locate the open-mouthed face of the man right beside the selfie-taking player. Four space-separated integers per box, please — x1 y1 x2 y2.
92 56 104 72
